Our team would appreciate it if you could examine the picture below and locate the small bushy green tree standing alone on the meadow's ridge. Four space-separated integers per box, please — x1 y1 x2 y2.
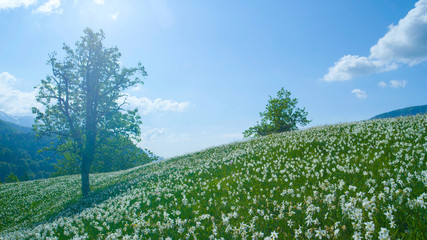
243 88 310 138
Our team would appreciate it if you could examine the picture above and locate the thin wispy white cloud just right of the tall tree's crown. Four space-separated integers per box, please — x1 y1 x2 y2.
120 95 191 115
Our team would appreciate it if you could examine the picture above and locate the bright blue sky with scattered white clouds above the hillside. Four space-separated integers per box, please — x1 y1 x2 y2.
0 0 427 157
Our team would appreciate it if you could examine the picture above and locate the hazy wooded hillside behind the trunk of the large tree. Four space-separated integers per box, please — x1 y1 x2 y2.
0 120 159 182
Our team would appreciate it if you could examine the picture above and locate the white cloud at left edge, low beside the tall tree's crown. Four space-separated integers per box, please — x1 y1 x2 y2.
0 72 40 116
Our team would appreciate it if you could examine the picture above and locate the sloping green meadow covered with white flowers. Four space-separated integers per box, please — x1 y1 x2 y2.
0 115 427 240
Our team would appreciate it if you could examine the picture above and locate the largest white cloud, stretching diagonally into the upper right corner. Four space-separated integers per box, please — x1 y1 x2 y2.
323 0 427 82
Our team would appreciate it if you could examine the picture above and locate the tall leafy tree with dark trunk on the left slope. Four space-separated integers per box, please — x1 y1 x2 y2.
33 28 147 197
